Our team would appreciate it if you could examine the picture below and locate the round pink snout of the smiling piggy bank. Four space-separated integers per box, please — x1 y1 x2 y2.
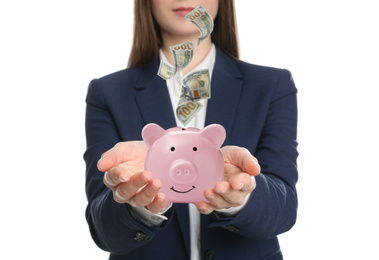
170 160 197 184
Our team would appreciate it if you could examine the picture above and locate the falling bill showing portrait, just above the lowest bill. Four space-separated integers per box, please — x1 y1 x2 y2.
179 69 211 105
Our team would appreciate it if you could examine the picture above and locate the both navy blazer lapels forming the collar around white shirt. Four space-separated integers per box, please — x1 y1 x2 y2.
135 46 243 143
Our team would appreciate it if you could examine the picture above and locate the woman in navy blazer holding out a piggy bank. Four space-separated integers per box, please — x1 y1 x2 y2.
84 0 298 259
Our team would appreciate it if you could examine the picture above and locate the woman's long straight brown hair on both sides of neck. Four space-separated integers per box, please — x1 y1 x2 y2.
128 0 239 68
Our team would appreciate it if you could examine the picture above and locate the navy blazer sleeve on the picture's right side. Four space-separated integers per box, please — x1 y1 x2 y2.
211 70 298 240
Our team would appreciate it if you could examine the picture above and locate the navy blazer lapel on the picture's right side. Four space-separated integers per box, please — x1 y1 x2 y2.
205 48 243 144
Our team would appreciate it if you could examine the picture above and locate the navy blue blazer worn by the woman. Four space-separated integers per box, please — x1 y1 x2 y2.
84 48 298 260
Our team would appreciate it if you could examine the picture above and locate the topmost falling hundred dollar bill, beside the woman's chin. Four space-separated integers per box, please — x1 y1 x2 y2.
186 5 214 46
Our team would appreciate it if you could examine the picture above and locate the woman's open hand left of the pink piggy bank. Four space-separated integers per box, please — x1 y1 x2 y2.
97 141 166 213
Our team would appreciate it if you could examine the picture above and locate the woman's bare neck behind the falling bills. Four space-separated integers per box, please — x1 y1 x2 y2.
162 35 212 75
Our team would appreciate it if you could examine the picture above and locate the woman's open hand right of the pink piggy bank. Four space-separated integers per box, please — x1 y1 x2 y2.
196 146 261 214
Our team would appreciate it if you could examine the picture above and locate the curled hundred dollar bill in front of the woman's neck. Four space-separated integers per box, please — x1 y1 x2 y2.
170 42 194 74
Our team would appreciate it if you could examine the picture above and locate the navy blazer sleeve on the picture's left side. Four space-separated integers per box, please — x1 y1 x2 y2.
84 80 172 254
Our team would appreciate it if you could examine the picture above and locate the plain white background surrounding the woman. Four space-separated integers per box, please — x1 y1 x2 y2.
0 0 379 260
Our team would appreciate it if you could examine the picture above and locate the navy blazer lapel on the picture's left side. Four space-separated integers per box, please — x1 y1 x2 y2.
135 59 176 129
